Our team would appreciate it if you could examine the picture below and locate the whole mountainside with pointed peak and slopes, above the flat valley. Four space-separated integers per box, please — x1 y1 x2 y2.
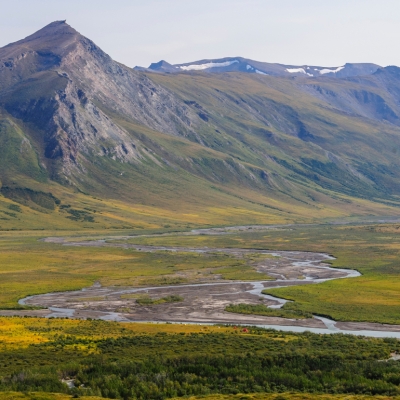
0 21 400 230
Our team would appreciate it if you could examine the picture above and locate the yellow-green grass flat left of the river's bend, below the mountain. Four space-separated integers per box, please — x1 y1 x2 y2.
0 232 247 309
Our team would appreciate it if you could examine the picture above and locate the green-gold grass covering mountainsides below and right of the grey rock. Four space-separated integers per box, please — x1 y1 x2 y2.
0 67 399 231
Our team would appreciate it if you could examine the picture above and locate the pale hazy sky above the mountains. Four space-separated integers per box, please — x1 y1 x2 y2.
0 0 400 67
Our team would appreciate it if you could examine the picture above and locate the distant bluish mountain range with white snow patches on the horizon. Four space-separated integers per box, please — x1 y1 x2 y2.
135 57 381 78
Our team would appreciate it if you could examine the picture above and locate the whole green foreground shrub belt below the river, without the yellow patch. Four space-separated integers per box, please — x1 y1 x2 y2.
0 328 400 400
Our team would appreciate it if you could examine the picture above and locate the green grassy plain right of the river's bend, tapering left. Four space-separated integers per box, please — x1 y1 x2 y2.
107 224 400 324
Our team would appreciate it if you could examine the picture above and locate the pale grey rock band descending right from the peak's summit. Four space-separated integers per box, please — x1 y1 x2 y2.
60 29 196 135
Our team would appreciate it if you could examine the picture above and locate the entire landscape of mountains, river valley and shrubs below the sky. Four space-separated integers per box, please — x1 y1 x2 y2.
0 21 400 400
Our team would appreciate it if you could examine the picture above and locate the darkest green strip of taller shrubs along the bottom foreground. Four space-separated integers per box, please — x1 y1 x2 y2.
1 352 400 399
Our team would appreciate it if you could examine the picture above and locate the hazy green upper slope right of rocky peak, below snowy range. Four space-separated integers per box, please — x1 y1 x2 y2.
151 73 400 202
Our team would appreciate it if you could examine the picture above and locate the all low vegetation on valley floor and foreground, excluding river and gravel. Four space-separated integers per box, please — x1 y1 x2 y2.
0 224 400 400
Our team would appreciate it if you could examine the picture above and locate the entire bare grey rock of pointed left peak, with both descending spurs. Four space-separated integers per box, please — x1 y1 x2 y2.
0 21 201 175
